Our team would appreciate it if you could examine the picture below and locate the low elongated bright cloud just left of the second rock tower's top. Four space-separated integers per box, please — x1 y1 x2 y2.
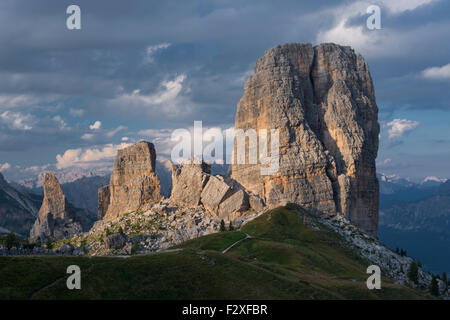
56 143 131 169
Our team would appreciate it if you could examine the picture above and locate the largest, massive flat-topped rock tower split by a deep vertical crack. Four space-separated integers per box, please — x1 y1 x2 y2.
232 44 379 235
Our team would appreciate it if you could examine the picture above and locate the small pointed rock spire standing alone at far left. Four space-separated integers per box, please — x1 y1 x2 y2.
30 172 95 241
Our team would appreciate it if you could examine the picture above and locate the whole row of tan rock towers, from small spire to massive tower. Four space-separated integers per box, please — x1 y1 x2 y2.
24 44 379 246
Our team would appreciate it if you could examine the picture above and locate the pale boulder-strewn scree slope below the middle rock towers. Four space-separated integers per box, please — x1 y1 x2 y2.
65 199 261 256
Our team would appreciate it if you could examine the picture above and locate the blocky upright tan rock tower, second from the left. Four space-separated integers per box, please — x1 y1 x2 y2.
98 141 161 219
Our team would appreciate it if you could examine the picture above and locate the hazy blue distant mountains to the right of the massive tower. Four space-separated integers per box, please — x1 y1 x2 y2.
378 175 450 273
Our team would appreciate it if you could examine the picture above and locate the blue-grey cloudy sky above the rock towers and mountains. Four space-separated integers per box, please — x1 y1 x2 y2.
0 0 450 181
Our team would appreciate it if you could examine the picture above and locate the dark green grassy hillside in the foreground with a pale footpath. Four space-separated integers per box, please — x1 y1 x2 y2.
0 207 428 299
